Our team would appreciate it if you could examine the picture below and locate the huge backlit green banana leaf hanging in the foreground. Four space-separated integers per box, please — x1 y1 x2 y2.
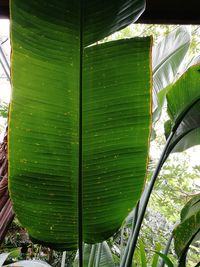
9 0 151 250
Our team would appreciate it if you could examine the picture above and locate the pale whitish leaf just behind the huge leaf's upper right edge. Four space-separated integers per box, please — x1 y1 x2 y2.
152 26 191 121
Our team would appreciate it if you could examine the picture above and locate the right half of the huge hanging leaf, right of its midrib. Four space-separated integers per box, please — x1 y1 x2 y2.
83 38 150 243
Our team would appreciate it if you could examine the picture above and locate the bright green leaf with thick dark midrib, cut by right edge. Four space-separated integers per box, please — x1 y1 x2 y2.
167 65 200 155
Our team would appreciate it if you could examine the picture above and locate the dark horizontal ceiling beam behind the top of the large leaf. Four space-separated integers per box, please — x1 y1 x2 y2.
0 0 200 24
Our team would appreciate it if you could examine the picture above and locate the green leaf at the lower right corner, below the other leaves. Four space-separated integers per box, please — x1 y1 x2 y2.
173 194 200 258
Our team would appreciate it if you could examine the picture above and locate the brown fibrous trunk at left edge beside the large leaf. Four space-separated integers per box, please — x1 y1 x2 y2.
0 131 15 243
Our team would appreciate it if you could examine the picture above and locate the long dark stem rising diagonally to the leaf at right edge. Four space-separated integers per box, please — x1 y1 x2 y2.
123 131 175 267
